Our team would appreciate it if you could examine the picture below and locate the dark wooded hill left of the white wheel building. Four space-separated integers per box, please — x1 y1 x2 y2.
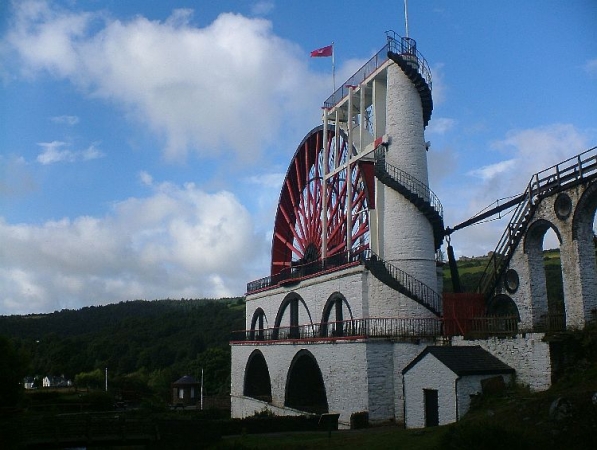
0 298 245 395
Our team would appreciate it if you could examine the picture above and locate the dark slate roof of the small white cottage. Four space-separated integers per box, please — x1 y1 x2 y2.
402 345 514 376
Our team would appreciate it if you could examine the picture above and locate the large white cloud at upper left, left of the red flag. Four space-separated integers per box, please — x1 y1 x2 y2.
7 1 329 161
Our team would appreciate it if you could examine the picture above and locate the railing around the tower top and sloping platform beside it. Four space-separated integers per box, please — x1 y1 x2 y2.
323 30 431 108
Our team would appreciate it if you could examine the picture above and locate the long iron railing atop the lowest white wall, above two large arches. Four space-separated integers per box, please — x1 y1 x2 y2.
231 318 442 342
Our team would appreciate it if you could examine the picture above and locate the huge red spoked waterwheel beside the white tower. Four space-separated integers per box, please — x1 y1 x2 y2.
271 126 373 275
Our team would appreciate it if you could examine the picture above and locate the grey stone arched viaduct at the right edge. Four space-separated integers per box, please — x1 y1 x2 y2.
498 183 597 330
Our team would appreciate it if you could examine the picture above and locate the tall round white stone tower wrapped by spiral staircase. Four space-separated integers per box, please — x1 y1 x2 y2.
377 34 441 291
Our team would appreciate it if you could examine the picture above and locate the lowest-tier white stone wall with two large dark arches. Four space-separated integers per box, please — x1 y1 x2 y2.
231 340 434 427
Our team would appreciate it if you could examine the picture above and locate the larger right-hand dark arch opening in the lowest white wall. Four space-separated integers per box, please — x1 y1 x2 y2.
284 349 328 414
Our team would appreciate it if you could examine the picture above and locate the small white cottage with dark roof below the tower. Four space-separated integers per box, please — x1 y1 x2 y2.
402 346 514 428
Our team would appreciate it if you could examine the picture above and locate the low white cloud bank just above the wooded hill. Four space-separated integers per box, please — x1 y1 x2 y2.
0 183 267 314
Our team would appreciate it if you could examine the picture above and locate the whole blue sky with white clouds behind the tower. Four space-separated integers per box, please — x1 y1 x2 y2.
0 0 597 314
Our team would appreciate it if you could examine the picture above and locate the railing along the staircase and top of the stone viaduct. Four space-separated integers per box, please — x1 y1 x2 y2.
477 147 597 296
